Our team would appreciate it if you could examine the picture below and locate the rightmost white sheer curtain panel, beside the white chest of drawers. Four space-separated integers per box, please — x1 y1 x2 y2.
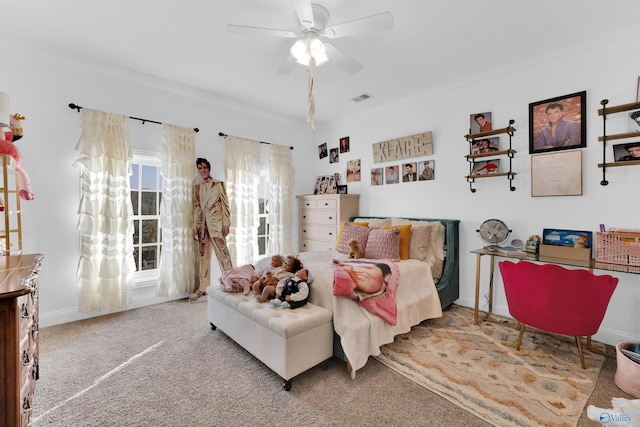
267 144 294 254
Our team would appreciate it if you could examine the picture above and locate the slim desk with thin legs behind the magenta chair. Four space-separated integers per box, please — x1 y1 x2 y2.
471 248 640 325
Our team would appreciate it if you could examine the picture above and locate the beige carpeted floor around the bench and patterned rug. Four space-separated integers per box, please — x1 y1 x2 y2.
31 300 629 427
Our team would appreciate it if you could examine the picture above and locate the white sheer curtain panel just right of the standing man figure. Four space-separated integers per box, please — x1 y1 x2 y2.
225 135 261 266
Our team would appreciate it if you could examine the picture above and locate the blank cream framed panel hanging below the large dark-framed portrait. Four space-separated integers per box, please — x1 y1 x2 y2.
531 150 582 197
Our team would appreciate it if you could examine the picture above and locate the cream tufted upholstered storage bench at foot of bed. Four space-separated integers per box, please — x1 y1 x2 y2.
207 285 333 391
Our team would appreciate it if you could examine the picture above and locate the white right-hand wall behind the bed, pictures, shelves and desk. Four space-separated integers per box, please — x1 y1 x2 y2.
308 23 640 344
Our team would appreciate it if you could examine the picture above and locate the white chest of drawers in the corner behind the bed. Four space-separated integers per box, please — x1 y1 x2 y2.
298 194 360 252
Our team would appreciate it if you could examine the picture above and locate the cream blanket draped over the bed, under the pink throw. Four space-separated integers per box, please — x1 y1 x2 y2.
298 251 442 378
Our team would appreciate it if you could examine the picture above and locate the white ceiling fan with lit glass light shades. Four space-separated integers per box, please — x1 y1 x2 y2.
227 0 393 74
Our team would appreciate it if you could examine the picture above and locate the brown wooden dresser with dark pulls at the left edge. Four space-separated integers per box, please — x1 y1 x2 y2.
0 254 44 427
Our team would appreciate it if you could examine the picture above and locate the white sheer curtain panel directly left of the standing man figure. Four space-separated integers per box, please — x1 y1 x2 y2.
156 124 196 296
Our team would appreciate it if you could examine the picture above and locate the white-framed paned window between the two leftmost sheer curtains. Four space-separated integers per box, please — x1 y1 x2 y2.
130 153 162 278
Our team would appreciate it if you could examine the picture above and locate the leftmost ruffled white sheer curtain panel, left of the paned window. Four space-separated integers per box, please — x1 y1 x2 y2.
74 108 136 314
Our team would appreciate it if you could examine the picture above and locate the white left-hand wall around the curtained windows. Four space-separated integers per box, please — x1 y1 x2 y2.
0 35 315 326
